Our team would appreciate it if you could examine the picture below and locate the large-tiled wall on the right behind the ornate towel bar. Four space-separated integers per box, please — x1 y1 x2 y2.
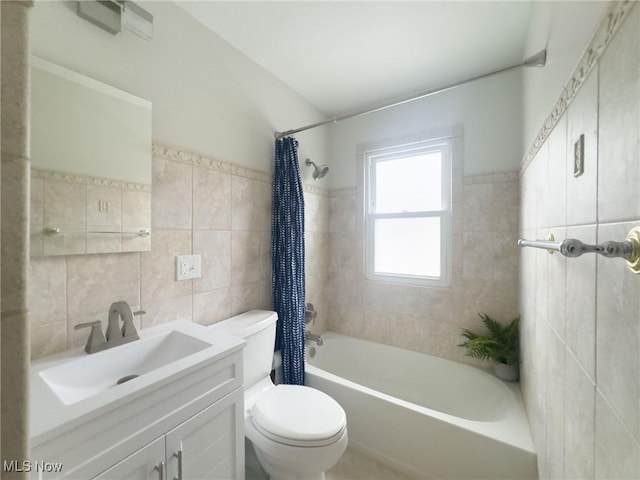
520 7 640 479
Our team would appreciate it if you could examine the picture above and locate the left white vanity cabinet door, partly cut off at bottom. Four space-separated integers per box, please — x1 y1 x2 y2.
93 437 165 480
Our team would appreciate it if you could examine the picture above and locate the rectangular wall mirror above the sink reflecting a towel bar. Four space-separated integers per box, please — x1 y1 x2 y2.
30 57 152 256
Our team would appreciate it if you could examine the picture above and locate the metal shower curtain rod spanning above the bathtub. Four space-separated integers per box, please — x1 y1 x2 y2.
274 50 547 140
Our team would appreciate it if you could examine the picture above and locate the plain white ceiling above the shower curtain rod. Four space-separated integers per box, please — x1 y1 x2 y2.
178 0 531 116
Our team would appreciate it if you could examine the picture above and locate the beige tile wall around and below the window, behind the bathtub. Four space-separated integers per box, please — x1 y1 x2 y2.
327 161 519 365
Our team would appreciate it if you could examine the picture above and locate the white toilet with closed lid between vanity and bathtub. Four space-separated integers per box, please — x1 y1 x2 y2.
211 310 348 480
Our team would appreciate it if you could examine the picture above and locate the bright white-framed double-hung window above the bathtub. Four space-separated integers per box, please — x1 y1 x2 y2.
365 140 451 286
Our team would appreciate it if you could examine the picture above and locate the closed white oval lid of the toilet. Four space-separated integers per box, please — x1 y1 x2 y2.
251 385 347 444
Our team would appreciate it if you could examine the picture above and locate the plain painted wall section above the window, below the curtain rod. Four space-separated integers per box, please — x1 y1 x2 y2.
327 70 522 188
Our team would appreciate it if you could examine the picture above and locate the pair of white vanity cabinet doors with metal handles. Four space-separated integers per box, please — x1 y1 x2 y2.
93 390 244 480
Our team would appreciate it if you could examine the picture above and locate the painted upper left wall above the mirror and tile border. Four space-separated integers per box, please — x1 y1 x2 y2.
31 1 325 172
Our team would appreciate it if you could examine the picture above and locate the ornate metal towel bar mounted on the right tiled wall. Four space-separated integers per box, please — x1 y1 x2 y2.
518 227 640 273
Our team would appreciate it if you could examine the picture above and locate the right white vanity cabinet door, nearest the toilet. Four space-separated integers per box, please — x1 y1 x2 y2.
166 389 244 480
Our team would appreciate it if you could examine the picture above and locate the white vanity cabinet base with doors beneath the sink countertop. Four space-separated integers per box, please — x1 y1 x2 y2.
28 340 244 480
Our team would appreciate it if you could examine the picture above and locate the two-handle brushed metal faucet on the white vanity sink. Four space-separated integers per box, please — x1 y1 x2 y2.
73 300 146 353
